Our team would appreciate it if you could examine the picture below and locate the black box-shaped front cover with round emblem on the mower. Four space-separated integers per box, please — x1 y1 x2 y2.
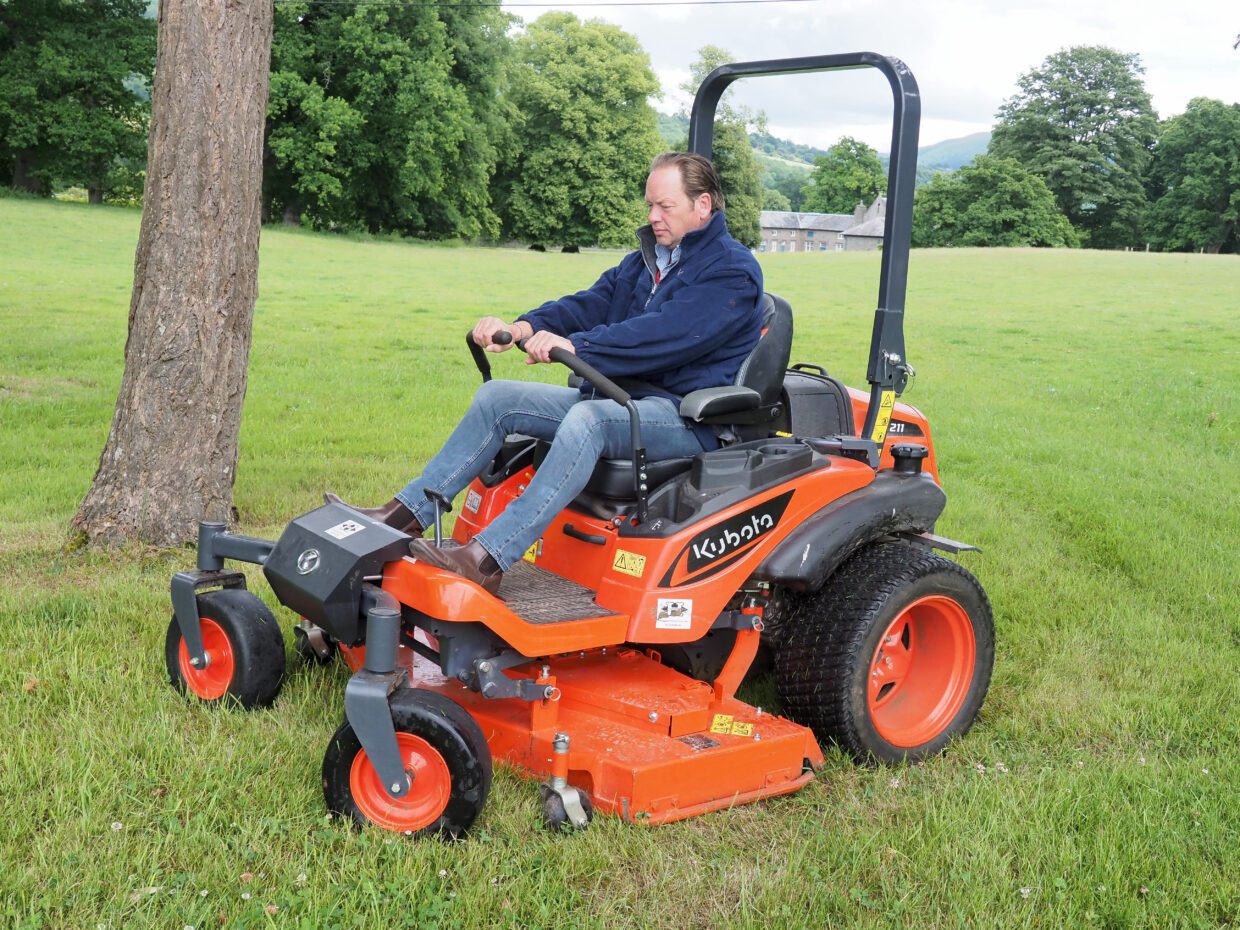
263 503 409 646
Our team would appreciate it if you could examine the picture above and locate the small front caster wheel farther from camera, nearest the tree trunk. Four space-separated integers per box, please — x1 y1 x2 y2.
164 588 284 709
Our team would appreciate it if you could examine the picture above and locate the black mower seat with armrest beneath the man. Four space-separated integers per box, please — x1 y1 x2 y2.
573 294 792 517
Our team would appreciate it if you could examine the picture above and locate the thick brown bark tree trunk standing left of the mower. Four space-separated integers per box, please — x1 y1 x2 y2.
73 0 273 544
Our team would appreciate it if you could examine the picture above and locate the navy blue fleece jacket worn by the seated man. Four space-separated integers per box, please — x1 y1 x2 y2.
517 212 763 449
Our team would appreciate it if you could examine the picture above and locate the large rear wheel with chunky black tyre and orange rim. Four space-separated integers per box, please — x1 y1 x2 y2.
776 543 994 763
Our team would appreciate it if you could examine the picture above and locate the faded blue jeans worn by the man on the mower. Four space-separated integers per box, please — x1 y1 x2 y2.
396 381 702 570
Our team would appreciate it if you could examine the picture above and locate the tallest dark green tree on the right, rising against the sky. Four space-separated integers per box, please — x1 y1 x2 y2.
990 46 1157 248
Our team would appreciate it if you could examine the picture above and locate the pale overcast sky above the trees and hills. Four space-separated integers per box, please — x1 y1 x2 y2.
505 0 1240 151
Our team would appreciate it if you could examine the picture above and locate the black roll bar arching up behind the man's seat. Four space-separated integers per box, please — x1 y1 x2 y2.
688 52 921 445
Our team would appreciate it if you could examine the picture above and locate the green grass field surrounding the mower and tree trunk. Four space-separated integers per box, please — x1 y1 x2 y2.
0 200 1240 930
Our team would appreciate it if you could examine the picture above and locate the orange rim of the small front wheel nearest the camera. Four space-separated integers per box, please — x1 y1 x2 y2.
348 733 453 833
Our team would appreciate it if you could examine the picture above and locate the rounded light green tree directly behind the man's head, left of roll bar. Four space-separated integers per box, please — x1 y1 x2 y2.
496 12 662 247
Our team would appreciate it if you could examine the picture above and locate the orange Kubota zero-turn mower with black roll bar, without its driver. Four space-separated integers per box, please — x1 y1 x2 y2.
166 53 994 836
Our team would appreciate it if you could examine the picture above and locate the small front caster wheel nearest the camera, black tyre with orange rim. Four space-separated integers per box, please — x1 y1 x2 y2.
322 688 491 838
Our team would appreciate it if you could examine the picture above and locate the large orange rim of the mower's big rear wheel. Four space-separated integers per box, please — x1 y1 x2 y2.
866 595 977 748
